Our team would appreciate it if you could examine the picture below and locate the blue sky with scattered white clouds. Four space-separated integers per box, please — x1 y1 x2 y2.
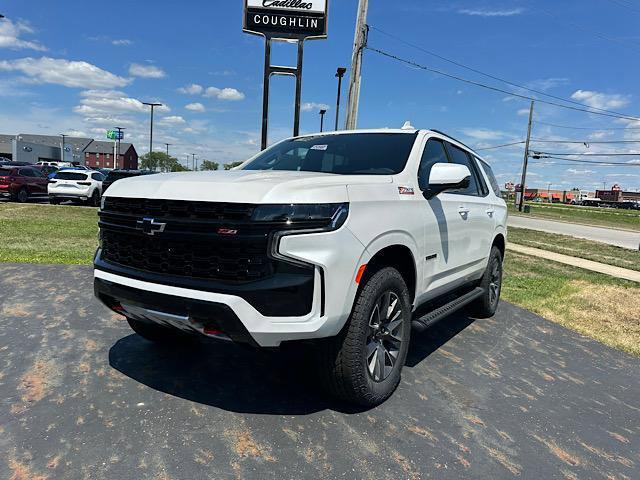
0 0 640 190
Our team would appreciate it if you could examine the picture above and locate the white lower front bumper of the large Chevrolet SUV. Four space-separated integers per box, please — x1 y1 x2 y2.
94 223 369 347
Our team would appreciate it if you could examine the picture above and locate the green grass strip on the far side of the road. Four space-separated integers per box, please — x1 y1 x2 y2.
509 203 640 232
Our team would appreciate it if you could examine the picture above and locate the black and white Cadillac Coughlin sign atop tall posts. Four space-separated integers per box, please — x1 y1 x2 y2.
244 0 329 39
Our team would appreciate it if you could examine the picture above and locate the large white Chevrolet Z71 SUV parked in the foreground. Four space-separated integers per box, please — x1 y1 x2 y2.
95 128 507 406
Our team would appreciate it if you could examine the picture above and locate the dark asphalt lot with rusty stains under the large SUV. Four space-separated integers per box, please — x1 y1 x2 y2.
0 264 640 480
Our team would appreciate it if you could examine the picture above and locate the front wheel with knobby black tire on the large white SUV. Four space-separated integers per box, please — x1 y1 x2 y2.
316 267 411 407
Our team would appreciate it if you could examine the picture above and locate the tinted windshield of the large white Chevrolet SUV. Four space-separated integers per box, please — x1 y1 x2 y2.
242 133 417 175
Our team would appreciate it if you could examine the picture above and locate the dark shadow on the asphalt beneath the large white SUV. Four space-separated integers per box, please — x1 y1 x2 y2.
109 316 473 415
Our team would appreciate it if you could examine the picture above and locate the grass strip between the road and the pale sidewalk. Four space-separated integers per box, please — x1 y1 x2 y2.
509 227 640 271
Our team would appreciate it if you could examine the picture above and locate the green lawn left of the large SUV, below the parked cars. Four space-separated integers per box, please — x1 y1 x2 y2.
0 203 98 264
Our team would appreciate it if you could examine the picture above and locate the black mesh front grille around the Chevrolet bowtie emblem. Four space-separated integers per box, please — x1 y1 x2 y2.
100 197 279 282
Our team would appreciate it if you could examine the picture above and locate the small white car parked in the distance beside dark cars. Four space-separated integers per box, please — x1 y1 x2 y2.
47 170 104 207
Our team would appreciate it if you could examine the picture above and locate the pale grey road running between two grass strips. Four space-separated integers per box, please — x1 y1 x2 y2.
509 215 640 250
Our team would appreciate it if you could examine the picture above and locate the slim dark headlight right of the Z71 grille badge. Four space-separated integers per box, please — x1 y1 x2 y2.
251 203 349 230
